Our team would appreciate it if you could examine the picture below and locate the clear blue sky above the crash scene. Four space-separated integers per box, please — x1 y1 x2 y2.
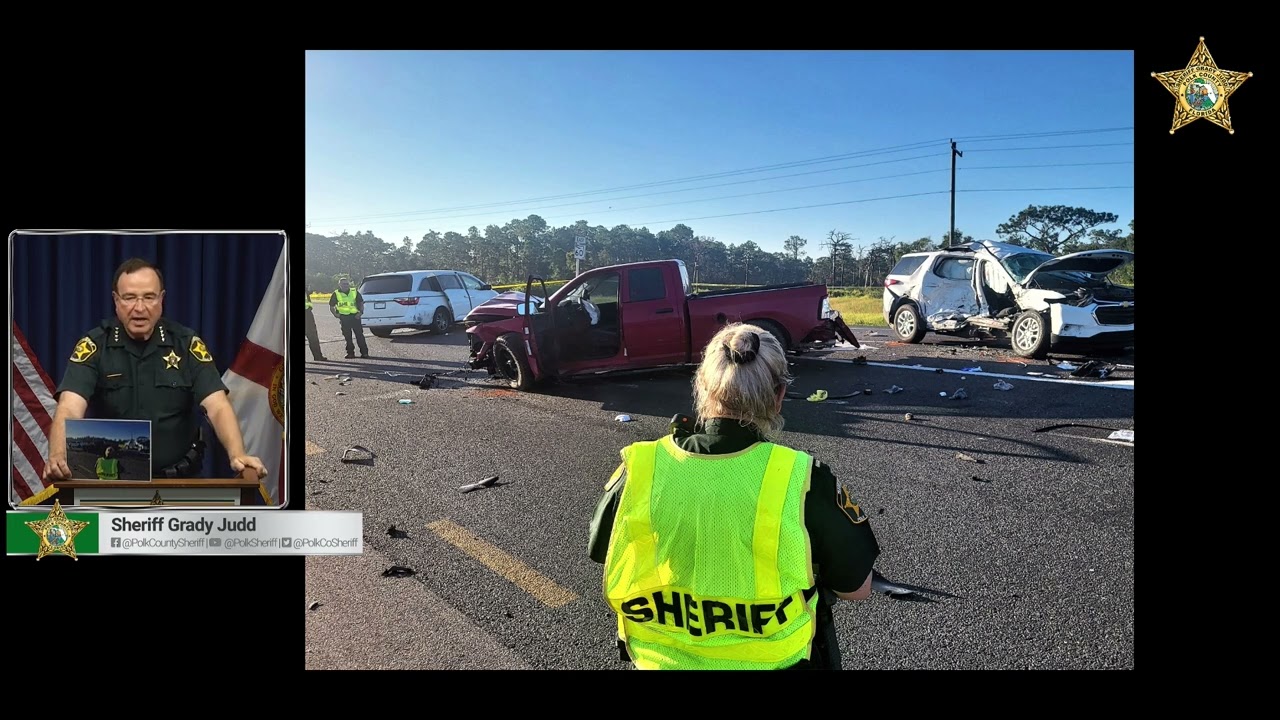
306 51 1134 256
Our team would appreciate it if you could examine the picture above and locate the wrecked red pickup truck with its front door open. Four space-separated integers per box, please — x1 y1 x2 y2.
463 260 860 389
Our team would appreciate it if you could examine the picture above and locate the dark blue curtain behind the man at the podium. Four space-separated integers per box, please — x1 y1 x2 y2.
12 233 284 478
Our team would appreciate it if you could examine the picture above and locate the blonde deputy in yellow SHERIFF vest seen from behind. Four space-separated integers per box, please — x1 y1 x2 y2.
589 324 879 670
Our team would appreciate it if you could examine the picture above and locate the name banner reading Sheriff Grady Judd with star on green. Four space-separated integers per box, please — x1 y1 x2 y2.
6 502 365 560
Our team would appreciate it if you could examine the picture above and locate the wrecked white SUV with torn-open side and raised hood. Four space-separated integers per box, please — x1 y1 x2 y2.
883 240 1133 357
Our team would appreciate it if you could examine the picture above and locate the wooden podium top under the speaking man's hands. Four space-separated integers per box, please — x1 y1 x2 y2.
51 468 262 507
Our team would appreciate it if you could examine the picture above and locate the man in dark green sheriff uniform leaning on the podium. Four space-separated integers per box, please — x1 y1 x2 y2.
45 259 266 480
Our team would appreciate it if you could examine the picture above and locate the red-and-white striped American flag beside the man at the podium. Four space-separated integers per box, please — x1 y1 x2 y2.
13 323 58 502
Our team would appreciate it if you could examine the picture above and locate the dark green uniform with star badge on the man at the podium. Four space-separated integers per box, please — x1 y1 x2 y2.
55 318 227 478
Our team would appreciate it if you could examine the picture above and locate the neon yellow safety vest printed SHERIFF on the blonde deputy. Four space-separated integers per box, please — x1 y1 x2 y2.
604 436 818 670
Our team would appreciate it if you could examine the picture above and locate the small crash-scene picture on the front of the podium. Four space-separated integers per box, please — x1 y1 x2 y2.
67 420 151 482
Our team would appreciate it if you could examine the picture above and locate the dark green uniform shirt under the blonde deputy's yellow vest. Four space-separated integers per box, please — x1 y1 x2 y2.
588 419 879 669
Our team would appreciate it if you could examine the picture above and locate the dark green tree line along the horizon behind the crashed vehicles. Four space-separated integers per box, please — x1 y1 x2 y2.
306 205 1133 292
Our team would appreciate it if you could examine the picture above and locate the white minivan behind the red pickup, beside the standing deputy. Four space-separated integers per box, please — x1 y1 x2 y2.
360 270 498 337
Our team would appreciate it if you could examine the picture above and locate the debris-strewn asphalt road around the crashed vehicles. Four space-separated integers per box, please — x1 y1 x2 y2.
300 313 1134 669
